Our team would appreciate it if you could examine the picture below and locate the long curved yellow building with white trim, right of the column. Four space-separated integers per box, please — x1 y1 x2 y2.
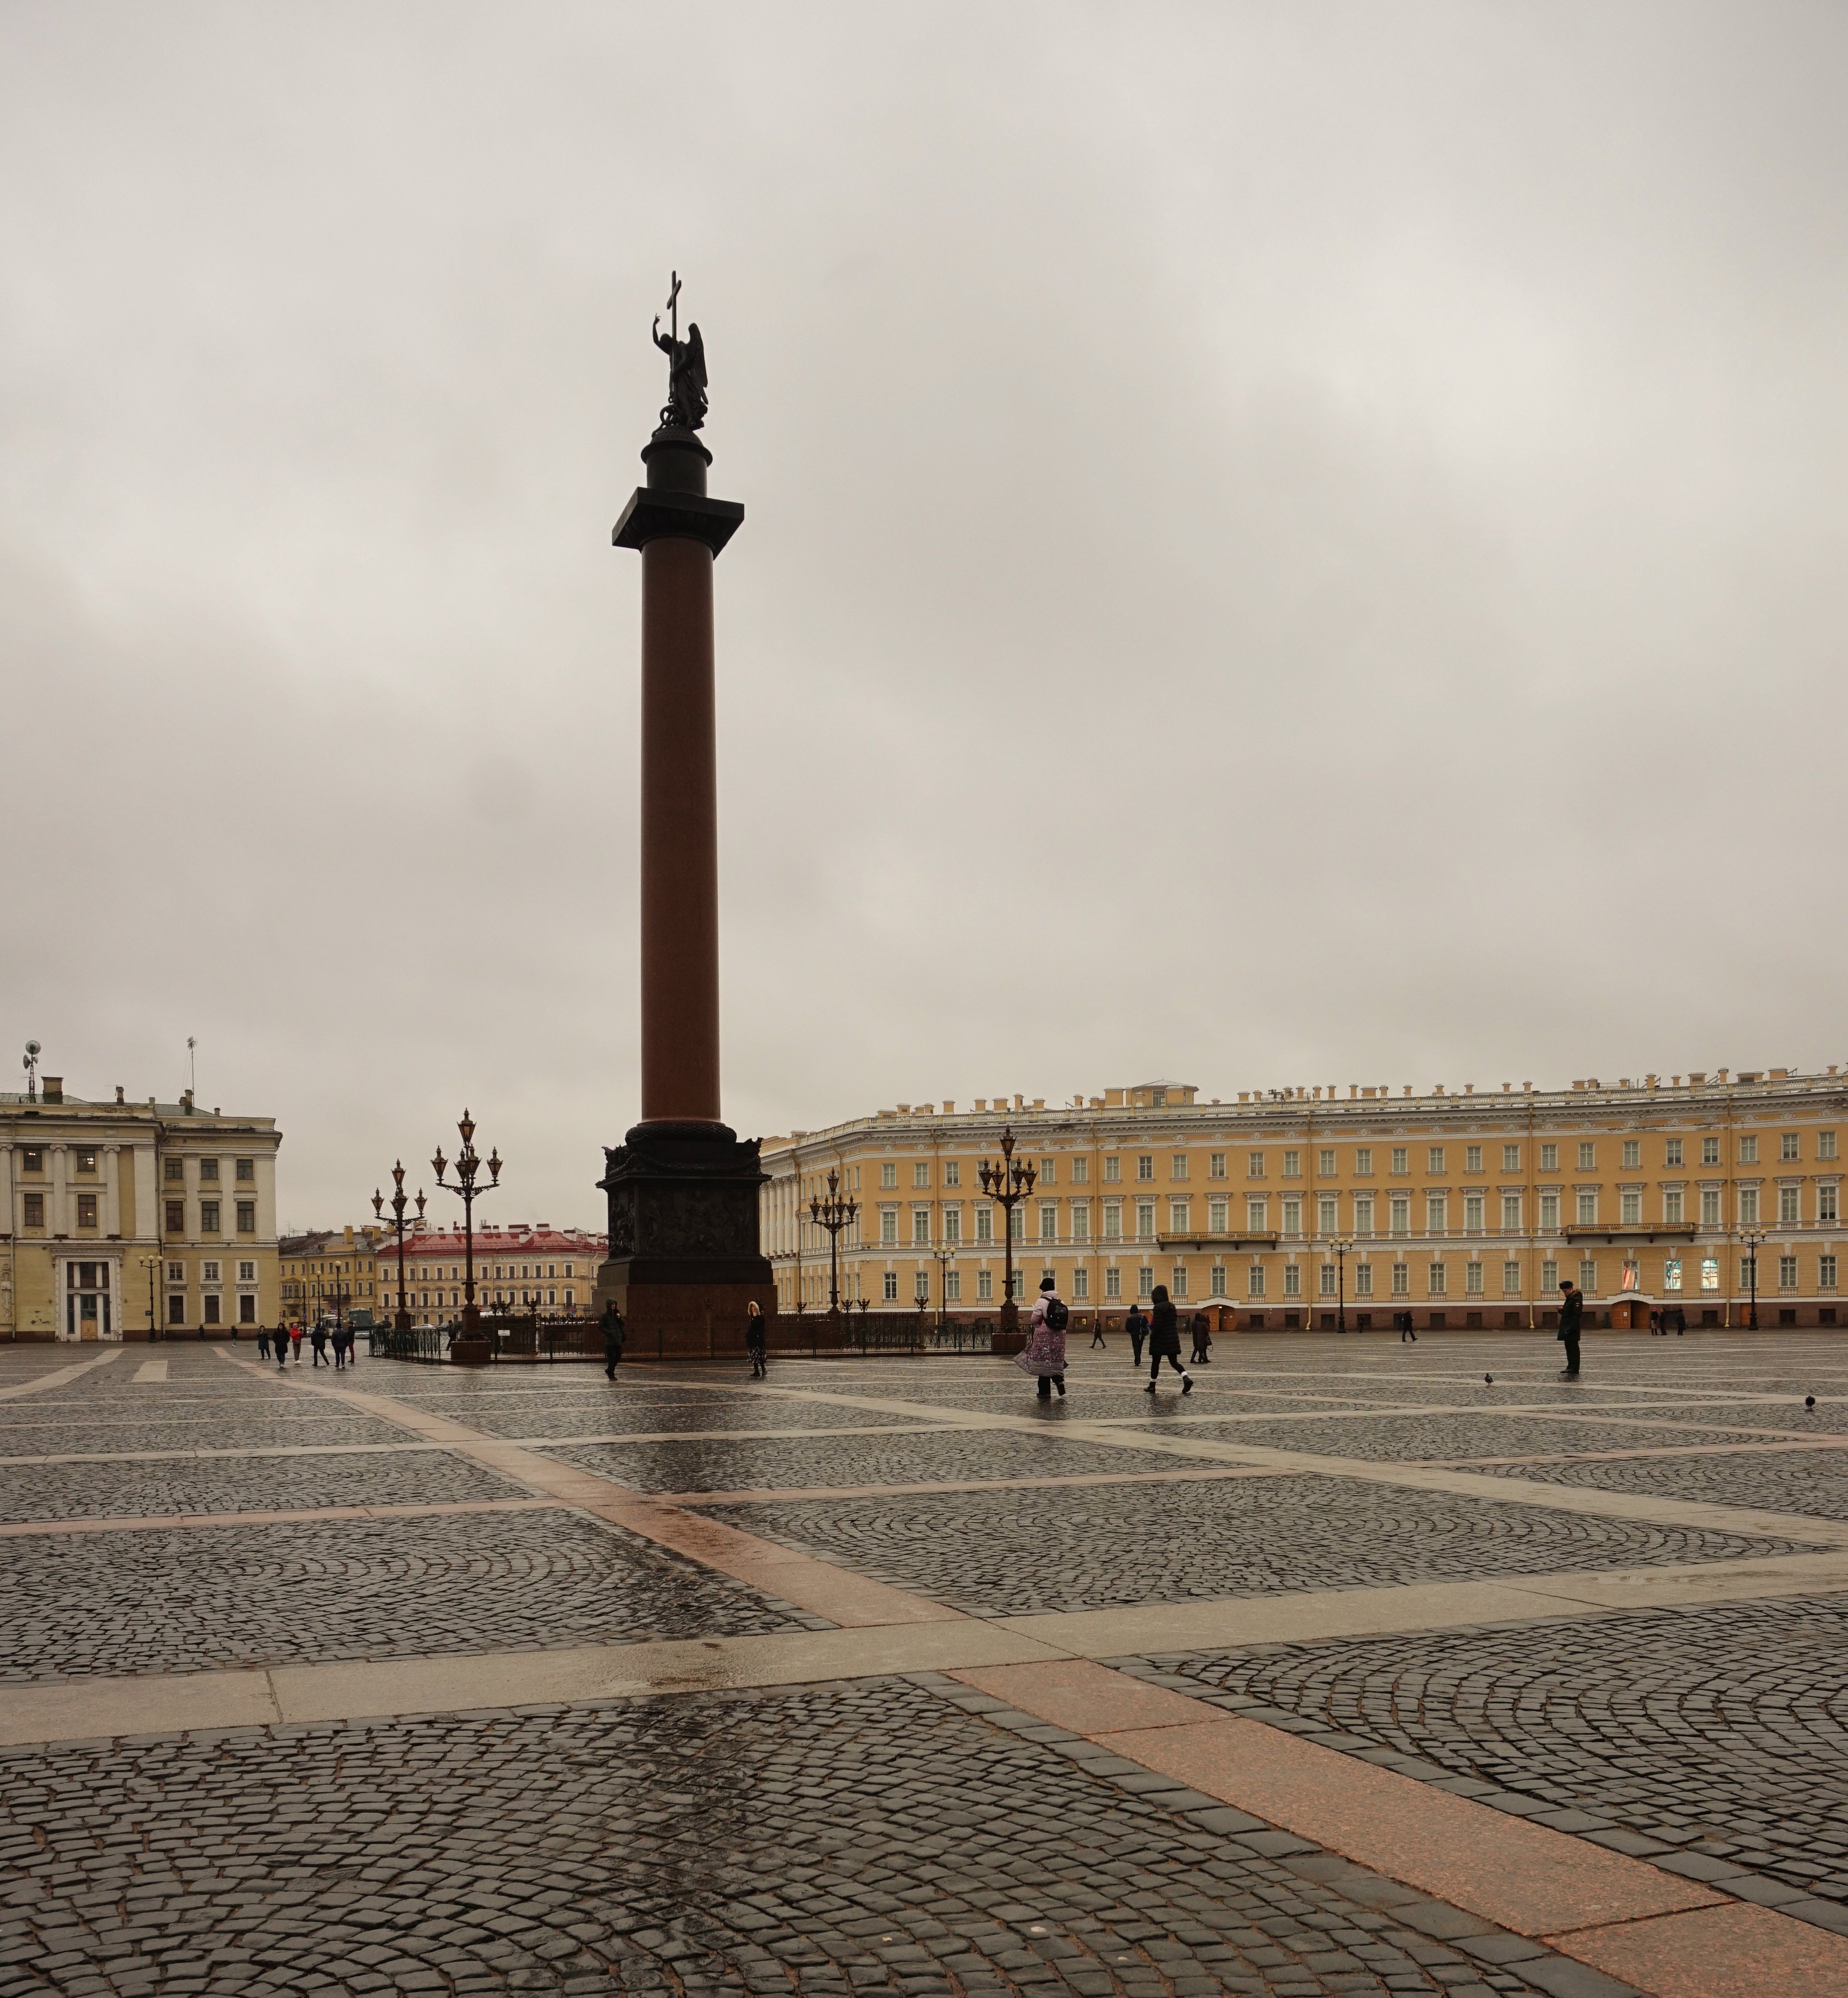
761 1067 1848 1331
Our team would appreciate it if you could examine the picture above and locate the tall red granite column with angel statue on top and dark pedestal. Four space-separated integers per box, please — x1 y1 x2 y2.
597 274 777 1357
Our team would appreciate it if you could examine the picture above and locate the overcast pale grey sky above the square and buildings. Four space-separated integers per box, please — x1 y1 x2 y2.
0 0 1848 1225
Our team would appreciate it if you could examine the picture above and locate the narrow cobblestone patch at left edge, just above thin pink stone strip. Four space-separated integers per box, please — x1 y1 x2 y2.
0 1450 530 1521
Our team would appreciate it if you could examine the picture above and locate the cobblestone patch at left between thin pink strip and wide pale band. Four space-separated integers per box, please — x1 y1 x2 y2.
0 1512 817 1682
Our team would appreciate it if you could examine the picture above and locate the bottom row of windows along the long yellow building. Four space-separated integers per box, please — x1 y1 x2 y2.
799 1255 1838 1305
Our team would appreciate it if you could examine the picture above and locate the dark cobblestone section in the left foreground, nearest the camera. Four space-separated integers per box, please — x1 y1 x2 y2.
0 1680 1590 1998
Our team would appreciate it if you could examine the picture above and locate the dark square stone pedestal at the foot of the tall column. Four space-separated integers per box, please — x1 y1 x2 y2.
595 1123 777 1361
